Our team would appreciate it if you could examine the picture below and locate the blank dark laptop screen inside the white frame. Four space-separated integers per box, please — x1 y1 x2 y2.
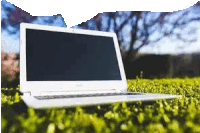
26 29 121 81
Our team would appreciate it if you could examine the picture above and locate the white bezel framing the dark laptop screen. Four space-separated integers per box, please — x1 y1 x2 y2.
20 23 127 93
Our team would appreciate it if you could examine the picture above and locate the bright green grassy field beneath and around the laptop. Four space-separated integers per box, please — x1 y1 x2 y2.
1 77 200 133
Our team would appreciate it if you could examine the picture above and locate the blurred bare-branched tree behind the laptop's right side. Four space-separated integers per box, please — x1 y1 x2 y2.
74 2 200 62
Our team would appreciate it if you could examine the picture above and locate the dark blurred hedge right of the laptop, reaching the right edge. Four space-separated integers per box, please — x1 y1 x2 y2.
123 53 200 79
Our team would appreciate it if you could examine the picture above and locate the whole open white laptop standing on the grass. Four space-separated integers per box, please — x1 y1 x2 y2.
20 23 180 109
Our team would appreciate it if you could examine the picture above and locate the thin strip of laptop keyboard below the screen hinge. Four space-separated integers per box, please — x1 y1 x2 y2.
34 92 141 100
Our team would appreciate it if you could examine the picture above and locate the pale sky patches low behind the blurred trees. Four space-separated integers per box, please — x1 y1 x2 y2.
1 0 200 54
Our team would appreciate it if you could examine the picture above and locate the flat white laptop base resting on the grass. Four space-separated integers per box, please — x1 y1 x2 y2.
22 93 181 109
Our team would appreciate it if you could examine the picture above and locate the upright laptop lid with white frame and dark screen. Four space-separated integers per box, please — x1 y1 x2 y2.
20 23 127 92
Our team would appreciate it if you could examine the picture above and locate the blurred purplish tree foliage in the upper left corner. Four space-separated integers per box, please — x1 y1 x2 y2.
1 1 66 35
